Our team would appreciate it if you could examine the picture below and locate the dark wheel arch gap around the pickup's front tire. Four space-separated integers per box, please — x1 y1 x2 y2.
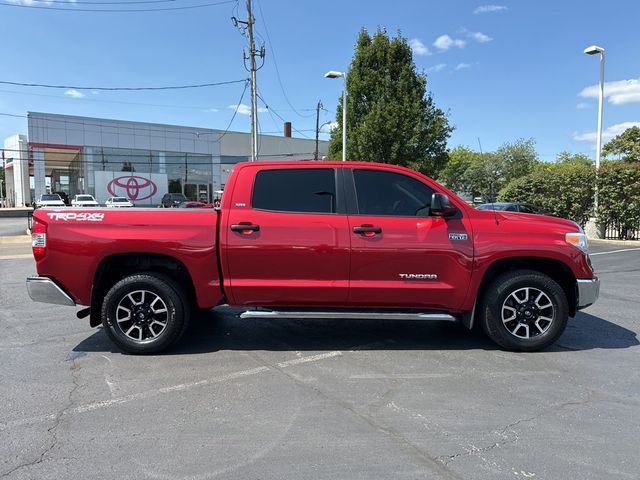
465 256 577 328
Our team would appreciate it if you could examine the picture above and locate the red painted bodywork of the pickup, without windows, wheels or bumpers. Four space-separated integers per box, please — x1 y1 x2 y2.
34 161 593 312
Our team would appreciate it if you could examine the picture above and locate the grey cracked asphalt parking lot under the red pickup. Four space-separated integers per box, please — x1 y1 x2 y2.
0 238 640 479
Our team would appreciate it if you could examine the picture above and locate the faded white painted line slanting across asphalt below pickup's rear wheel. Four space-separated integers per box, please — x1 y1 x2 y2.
0 351 342 431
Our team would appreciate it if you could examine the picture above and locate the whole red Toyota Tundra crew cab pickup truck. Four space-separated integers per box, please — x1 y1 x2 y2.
27 161 600 353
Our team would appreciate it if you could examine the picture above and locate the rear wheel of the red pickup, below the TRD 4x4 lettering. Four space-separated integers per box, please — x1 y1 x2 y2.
101 272 190 354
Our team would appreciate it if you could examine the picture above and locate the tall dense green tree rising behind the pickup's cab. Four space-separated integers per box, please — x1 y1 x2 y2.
328 28 453 176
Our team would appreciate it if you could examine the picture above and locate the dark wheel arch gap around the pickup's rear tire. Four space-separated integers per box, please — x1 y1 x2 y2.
89 252 197 327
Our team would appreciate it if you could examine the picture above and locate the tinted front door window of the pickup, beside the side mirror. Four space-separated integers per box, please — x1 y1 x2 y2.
353 170 434 217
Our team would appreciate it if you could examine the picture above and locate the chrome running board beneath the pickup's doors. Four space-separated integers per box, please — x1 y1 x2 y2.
240 310 459 322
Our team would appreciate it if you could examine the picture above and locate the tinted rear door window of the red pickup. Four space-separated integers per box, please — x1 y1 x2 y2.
251 168 336 213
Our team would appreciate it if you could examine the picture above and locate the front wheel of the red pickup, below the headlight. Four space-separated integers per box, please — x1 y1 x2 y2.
479 270 569 352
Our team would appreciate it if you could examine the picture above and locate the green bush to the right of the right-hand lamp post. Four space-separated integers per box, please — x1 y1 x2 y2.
598 161 640 240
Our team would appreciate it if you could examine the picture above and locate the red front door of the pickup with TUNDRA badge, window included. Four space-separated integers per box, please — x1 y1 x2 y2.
345 169 473 309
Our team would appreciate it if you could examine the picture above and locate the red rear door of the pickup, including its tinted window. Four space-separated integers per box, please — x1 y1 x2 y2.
220 165 351 306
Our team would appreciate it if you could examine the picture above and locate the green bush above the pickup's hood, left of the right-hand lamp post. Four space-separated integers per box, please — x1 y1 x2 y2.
498 164 595 226
